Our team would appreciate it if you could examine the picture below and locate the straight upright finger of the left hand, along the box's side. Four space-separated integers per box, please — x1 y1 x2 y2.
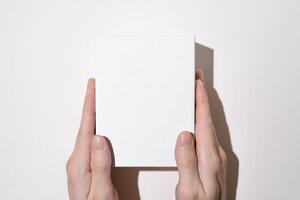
73 78 95 171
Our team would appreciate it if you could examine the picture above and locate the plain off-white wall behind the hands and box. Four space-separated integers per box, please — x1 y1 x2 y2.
0 0 300 200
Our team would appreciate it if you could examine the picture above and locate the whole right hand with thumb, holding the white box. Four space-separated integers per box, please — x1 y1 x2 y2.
175 71 227 200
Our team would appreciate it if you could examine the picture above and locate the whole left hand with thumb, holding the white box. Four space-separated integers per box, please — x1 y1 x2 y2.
67 79 119 200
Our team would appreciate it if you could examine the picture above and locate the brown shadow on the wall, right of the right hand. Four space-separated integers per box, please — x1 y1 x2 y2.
195 43 239 200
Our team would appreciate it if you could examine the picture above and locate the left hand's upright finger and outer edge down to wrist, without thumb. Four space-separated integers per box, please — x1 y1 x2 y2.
66 79 95 199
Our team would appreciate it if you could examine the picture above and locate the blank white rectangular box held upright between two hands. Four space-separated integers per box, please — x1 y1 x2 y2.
94 36 195 167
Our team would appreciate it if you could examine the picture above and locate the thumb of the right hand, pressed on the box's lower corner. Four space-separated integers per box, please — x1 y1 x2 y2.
175 132 200 191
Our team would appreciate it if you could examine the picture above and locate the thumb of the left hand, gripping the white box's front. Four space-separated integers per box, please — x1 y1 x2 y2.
91 135 112 189
